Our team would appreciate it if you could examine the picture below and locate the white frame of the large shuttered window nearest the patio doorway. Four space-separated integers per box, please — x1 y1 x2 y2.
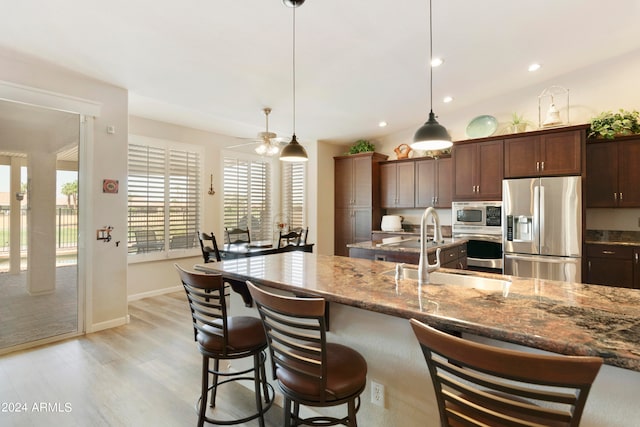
126 134 205 264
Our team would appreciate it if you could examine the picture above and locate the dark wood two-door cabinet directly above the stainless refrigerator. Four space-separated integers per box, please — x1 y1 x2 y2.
504 129 585 178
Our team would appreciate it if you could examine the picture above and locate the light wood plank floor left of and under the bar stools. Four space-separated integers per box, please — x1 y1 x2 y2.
0 292 282 427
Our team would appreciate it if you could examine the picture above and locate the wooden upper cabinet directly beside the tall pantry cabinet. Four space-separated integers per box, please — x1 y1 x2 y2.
380 160 415 208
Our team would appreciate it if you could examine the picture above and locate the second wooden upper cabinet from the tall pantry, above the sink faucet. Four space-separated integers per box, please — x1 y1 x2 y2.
415 157 453 208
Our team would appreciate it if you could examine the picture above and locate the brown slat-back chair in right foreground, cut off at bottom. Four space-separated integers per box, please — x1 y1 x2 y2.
410 319 603 427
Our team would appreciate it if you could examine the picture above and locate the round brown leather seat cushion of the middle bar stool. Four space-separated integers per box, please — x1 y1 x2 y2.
276 343 367 401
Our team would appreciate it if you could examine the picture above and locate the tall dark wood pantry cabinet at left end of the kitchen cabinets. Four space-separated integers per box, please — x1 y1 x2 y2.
334 153 387 256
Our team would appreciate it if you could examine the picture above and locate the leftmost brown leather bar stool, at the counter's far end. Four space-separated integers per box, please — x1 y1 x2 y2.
174 264 275 427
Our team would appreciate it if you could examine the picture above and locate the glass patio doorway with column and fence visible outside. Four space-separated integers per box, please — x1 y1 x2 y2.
0 101 82 353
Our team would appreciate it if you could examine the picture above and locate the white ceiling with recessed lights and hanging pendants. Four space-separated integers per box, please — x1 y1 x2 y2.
0 0 640 142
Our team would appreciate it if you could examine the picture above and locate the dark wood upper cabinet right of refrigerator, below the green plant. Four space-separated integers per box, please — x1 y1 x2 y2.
586 135 640 208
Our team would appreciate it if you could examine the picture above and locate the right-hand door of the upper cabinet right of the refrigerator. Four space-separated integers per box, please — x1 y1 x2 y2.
616 139 640 208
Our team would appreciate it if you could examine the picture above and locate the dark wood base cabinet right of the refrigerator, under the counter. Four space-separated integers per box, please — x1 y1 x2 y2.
586 244 639 288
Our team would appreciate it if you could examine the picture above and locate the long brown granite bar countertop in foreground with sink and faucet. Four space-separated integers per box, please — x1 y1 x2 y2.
196 252 640 371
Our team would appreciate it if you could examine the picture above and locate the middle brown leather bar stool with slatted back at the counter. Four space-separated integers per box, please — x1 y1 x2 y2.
247 281 367 427
